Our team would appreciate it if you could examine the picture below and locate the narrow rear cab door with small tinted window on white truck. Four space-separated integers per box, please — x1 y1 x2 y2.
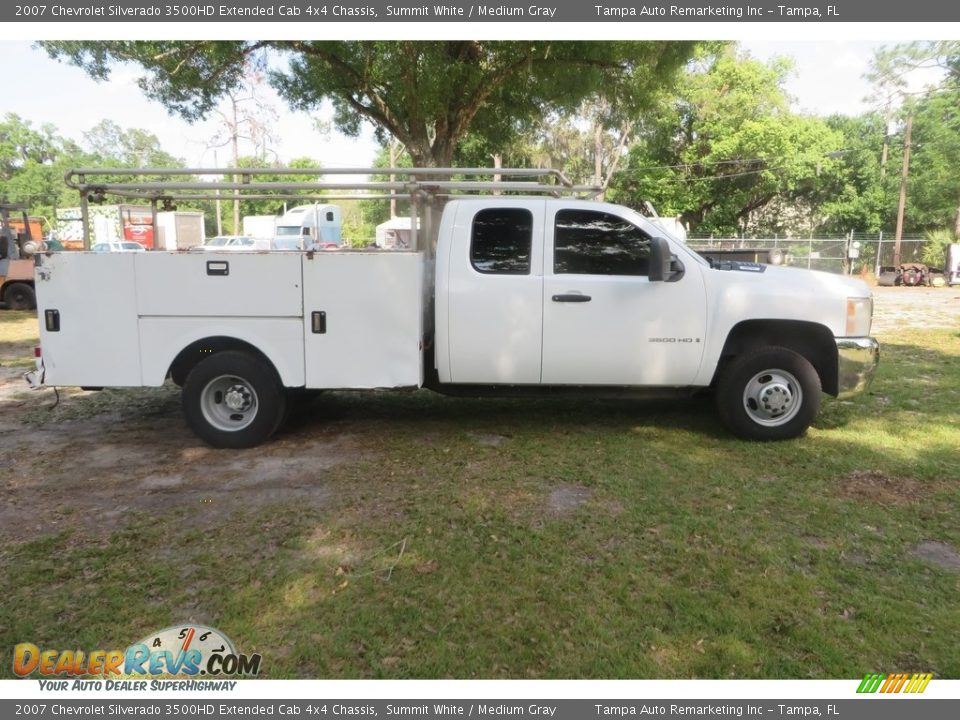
436 198 546 385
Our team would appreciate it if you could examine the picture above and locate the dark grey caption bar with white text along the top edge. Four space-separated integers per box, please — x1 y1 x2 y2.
7 0 960 24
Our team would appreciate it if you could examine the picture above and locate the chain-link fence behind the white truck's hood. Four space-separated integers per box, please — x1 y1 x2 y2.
687 232 925 274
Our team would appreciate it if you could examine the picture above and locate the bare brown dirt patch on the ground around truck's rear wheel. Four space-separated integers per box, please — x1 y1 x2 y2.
0 391 361 543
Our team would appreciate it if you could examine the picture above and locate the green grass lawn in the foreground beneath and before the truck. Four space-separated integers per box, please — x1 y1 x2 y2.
0 330 960 678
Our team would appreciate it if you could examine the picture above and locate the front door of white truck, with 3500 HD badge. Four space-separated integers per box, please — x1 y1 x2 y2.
542 201 706 386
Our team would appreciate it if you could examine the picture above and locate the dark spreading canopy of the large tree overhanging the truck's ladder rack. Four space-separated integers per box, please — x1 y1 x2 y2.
41 40 695 167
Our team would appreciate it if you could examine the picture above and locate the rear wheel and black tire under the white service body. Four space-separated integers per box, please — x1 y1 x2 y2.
183 350 287 448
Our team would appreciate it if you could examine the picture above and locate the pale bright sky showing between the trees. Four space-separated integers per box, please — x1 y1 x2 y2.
0 40 944 167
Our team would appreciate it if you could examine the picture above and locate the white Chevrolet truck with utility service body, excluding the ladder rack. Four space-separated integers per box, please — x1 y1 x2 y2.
28 172 879 447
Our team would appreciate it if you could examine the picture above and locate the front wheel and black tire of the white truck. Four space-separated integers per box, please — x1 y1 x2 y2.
716 347 821 440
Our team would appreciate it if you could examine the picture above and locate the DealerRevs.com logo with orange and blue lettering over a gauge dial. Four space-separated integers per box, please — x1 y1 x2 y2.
13 625 261 679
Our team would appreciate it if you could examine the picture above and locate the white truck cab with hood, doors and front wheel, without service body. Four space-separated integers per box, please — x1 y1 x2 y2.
435 198 878 439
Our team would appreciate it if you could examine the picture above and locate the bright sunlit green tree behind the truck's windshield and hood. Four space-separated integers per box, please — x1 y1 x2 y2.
612 47 843 233
